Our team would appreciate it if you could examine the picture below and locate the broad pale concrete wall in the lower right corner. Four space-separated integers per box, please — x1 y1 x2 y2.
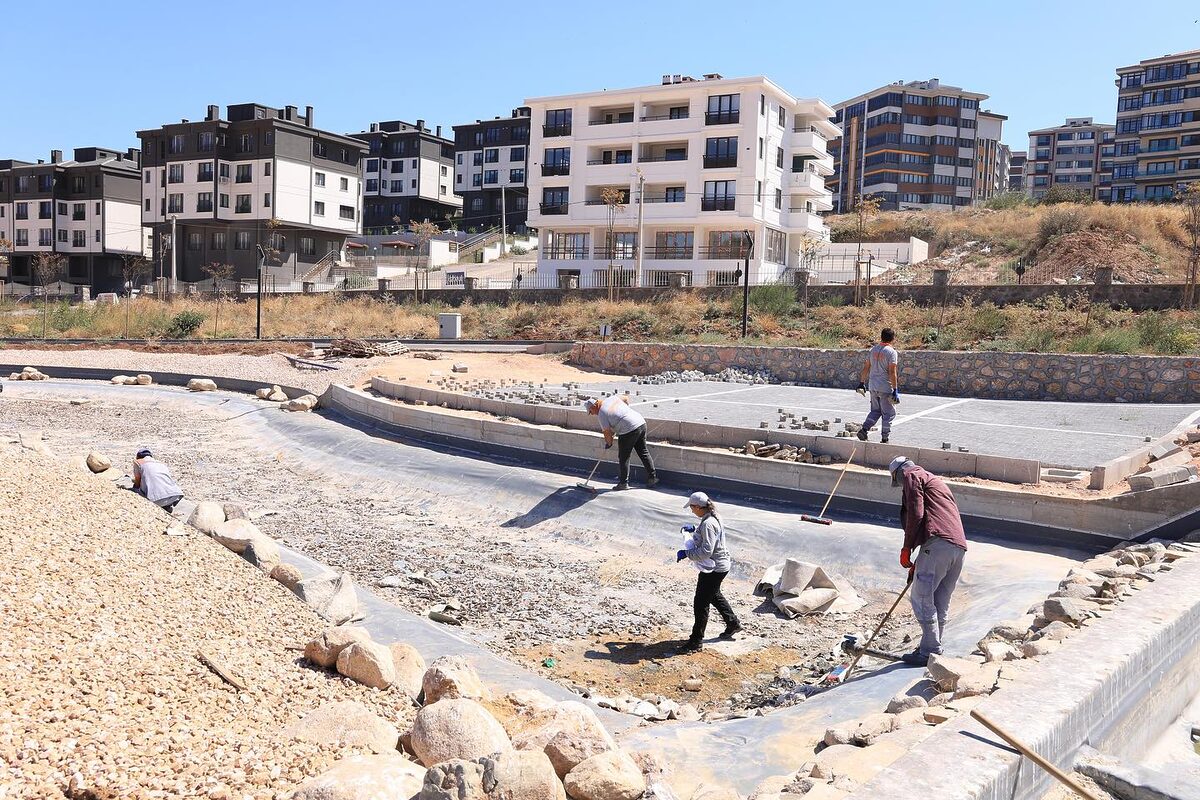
850 555 1200 800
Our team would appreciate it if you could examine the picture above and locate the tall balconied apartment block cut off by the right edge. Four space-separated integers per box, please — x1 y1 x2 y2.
1099 50 1200 203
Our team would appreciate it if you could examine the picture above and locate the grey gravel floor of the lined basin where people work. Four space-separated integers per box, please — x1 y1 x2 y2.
0 383 911 715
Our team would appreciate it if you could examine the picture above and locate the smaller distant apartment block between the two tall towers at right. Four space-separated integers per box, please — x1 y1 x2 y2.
1025 116 1114 200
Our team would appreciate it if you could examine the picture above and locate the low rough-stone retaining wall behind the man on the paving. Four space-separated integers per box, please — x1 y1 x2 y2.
570 342 1200 403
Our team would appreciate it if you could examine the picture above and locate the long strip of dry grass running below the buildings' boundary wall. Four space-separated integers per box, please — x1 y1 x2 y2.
0 292 1200 354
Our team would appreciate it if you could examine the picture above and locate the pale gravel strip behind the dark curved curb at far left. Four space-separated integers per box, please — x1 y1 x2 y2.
0 348 385 395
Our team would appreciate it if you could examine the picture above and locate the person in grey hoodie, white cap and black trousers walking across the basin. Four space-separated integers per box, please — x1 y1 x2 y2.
676 492 742 655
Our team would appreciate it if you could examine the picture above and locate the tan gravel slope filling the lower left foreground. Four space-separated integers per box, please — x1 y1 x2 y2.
0 441 410 800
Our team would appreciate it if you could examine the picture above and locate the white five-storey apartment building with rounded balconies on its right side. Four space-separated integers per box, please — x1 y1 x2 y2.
526 74 838 285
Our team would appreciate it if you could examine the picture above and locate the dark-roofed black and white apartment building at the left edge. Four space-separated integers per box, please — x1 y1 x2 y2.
0 148 148 291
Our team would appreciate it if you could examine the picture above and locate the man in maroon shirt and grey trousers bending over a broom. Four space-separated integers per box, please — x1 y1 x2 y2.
888 456 967 667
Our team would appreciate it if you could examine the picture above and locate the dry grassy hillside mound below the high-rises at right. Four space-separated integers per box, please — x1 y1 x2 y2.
827 203 1190 283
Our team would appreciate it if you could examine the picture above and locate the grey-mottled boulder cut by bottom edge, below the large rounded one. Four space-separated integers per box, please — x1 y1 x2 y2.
420 751 566 800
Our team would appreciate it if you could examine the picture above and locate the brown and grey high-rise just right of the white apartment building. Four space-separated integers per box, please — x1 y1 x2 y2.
828 78 1004 212
